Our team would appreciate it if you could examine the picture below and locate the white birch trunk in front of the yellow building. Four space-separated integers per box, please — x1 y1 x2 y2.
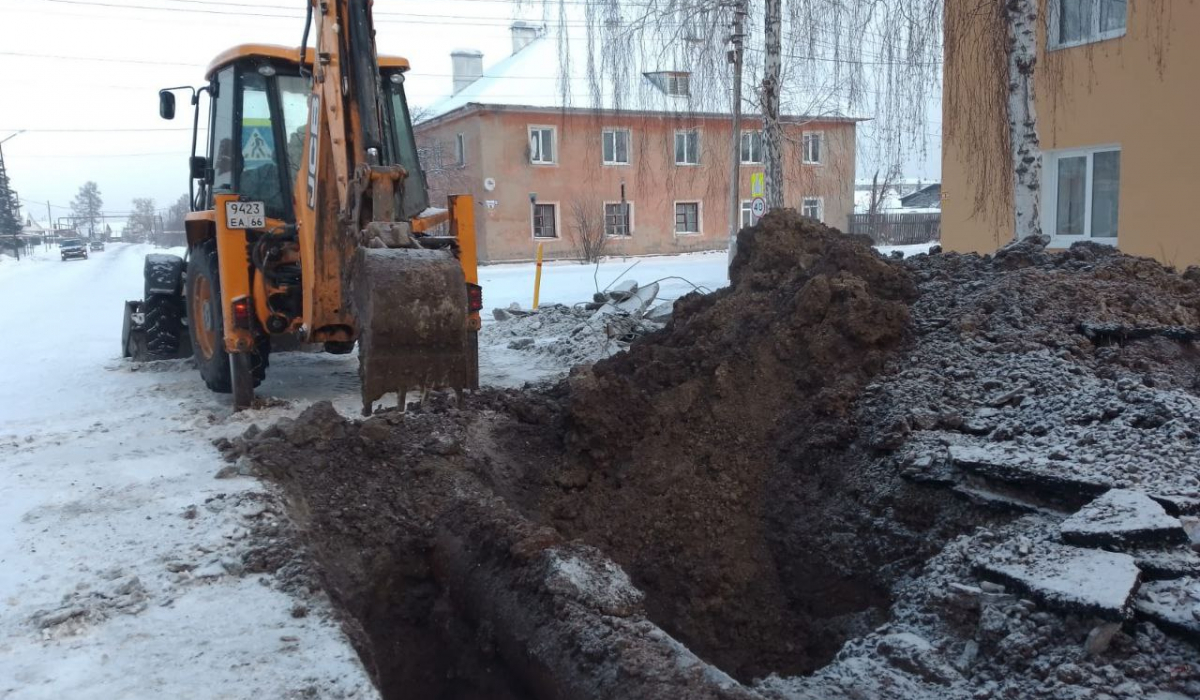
1006 0 1042 239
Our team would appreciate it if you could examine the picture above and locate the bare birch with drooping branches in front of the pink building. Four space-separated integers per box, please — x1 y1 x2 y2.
541 0 945 216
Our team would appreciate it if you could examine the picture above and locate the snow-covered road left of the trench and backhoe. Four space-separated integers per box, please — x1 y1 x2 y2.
0 245 374 700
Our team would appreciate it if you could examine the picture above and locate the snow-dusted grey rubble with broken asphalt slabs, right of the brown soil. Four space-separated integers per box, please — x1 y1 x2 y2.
766 239 1200 700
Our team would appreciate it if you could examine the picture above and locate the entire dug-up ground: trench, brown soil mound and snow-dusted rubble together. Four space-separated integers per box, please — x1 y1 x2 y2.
222 213 1200 700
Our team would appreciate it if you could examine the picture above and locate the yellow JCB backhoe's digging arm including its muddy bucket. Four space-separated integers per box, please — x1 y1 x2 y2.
295 0 478 414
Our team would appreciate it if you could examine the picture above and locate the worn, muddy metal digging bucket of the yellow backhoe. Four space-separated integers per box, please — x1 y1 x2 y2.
350 247 470 415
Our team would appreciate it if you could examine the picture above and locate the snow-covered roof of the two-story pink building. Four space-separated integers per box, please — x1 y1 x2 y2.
426 30 862 121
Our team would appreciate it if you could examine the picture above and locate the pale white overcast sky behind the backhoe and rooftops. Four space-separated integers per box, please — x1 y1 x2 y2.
0 0 937 228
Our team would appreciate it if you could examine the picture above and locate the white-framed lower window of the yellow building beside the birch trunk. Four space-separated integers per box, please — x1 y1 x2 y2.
1042 146 1121 245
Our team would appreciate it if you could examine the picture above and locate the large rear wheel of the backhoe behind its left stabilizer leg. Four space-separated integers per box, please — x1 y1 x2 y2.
187 240 271 394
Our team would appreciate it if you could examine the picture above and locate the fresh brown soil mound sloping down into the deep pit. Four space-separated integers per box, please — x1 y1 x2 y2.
539 213 993 678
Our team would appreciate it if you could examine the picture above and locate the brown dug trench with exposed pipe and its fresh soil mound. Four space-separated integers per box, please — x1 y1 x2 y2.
230 214 1008 699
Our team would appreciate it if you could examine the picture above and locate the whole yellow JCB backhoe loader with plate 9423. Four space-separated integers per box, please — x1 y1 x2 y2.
122 0 482 413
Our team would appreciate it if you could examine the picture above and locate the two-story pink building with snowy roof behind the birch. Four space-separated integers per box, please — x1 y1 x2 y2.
416 23 858 262
